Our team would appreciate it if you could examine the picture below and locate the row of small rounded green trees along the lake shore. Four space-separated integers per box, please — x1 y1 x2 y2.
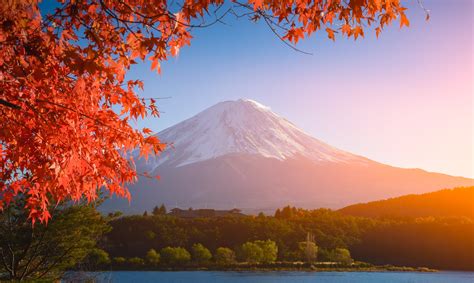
87 240 353 269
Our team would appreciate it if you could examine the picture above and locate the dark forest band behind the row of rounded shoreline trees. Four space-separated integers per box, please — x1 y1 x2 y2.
99 188 474 270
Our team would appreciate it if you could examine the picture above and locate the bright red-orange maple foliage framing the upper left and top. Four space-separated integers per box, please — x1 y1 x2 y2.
0 0 409 223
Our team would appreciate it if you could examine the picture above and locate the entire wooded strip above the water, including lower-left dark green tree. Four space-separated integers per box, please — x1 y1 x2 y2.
0 187 474 280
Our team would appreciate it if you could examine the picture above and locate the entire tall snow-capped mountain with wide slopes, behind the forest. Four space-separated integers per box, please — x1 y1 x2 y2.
103 99 474 213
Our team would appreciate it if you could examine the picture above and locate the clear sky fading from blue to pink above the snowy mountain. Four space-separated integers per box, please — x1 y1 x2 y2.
44 0 474 177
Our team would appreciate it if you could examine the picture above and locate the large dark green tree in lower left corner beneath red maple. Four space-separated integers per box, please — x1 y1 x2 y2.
0 199 109 280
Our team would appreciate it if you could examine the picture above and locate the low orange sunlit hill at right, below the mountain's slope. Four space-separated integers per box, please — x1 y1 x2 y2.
339 187 474 220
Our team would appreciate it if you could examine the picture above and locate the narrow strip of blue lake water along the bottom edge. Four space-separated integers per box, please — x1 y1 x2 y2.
70 271 474 283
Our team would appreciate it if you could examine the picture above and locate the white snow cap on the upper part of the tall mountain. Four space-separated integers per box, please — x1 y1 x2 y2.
139 99 368 170
